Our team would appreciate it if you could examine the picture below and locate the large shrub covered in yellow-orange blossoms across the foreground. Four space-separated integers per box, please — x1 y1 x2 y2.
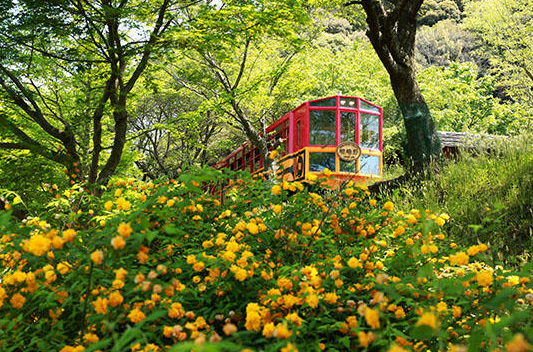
0 171 533 352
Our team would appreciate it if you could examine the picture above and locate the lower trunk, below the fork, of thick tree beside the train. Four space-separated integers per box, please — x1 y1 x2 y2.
390 66 441 172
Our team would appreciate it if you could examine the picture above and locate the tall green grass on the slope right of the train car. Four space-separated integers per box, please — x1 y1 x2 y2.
385 135 533 264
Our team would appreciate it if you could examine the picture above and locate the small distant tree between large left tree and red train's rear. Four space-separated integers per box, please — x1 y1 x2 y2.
130 89 222 179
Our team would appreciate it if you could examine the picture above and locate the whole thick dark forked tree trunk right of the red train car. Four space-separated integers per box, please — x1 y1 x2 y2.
348 0 441 172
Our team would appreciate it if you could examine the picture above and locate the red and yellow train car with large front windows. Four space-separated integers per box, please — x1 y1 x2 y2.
215 95 383 186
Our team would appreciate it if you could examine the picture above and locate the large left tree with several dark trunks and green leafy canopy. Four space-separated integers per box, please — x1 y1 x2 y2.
0 0 176 190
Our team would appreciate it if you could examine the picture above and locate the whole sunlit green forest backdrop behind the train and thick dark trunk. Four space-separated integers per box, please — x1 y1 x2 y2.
0 0 533 201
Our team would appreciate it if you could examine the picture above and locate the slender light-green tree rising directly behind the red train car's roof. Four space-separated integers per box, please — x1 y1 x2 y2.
172 0 308 173
